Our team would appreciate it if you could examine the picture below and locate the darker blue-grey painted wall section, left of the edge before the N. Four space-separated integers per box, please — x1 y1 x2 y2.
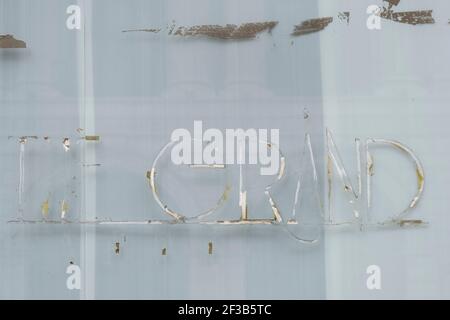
0 0 326 299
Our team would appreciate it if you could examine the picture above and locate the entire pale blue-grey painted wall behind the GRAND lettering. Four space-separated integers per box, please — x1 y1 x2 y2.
0 0 450 299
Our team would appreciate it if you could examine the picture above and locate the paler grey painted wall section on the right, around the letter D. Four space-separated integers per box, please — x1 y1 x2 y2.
319 0 450 299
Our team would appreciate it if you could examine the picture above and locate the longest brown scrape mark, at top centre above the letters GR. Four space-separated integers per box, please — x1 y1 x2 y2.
169 21 278 40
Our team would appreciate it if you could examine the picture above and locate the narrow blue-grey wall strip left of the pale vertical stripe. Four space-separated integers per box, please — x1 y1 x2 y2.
0 0 81 299
